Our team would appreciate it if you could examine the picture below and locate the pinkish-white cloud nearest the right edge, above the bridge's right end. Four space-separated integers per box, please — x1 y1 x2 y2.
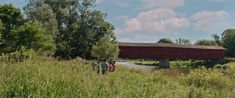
192 10 230 30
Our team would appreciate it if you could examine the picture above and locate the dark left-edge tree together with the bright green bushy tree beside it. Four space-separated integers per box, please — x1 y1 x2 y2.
0 4 55 53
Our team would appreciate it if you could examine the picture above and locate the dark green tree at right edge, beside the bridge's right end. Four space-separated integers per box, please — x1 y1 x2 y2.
222 29 235 57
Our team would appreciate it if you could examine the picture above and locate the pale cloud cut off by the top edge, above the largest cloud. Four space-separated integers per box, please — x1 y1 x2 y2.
142 0 184 8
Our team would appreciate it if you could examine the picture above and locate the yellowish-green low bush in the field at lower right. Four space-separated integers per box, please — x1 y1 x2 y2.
186 68 233 88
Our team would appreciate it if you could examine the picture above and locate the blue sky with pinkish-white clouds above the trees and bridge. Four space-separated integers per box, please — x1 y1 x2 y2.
0 0 235 42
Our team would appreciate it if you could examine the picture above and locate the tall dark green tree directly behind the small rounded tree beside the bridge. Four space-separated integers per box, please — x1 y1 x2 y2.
72 11 116 57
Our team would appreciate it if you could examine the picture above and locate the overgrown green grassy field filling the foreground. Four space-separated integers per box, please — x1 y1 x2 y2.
0 58 235 98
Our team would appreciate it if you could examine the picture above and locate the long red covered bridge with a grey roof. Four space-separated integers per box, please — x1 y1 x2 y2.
119 42 225 68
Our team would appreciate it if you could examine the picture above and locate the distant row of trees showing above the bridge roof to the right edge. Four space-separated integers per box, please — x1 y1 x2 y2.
157 29 235 57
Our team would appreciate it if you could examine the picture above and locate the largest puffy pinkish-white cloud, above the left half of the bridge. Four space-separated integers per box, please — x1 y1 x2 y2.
124 8 190 33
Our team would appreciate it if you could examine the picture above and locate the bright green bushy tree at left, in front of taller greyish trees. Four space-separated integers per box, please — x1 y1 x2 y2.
9 22 55 52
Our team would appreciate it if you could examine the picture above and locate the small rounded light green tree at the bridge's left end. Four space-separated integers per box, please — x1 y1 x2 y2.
92 35 119 60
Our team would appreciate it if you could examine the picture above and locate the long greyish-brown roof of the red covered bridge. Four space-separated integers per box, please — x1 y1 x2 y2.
118 42 225 50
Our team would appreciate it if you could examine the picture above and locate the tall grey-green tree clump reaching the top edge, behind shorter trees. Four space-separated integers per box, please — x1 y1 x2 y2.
24 0 115 58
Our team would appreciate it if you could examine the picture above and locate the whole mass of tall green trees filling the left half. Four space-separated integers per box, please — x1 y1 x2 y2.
0 0 119 59
